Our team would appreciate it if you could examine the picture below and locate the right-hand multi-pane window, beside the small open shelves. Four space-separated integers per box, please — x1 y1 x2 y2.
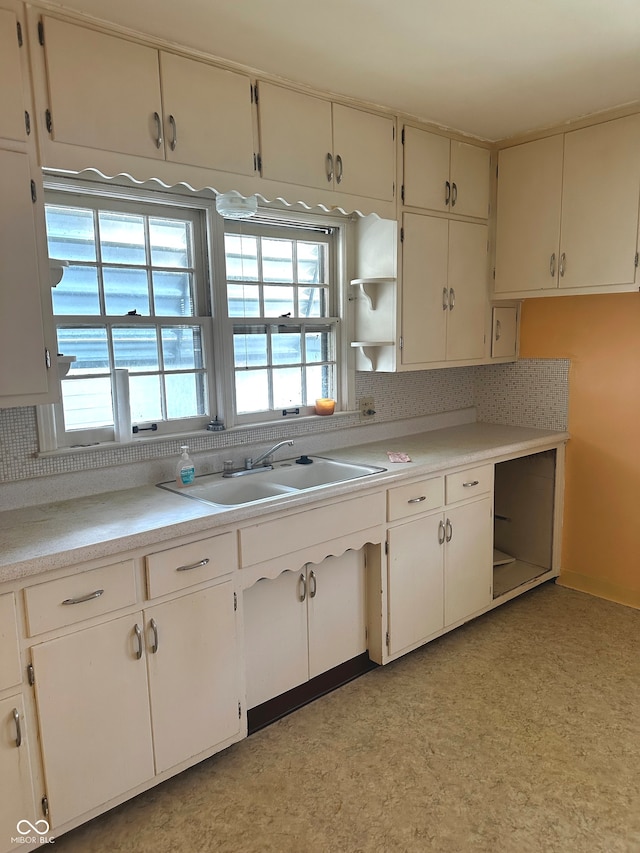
225 222 338 422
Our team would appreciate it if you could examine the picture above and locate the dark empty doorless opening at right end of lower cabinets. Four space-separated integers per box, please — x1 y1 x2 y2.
493 450 556 599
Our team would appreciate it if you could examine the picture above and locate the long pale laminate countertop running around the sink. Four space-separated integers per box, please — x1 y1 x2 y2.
0 423 569 582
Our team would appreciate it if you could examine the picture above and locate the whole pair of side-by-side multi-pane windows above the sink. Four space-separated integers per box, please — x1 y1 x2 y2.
45 182 344 448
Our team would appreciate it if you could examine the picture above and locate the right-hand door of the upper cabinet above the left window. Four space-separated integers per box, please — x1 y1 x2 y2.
160 51 254 175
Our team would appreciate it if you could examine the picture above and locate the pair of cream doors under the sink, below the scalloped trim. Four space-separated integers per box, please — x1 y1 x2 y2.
244 551 367 708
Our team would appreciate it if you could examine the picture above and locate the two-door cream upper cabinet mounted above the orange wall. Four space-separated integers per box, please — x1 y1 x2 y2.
494 115 640 296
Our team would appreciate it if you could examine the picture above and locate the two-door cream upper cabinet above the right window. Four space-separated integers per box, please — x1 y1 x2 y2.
258 82 395 201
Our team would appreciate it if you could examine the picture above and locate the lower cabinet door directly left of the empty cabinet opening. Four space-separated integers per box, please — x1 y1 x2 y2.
444 498 493 625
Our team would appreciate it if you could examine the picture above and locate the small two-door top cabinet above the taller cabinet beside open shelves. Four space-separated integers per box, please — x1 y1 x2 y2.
403 125 490 219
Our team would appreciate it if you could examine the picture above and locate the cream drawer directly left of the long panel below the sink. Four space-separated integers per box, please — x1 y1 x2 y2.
146 533 238 598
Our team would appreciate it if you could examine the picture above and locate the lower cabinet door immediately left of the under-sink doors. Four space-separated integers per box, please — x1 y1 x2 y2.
145 581 240 773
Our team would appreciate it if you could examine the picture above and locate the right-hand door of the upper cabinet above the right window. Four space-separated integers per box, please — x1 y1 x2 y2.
333 104 396 201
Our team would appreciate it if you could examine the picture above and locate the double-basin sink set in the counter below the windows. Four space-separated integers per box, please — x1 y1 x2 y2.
158 456 386 506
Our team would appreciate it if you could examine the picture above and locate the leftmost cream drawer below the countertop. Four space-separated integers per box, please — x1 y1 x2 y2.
24 560 136 637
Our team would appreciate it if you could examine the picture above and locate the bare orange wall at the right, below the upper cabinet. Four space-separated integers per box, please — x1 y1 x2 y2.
520 293 640 607
